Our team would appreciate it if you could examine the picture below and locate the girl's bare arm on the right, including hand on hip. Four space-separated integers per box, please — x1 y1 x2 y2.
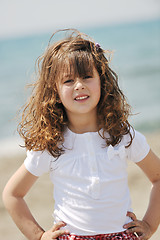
126 150 160 239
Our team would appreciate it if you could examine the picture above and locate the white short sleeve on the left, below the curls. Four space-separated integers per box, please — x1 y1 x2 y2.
24 150 51 177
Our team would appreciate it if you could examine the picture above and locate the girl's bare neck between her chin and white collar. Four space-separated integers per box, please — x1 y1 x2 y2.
68 114 99 133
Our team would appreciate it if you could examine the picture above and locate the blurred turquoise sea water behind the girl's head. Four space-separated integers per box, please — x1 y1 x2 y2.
0 20 160 140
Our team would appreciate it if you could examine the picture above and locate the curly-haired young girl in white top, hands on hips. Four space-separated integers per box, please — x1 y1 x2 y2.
3 30 160 240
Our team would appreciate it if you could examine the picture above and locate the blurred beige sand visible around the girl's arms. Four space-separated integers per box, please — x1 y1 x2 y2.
0 130 160 240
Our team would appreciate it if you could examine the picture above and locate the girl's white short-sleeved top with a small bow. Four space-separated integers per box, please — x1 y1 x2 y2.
24 129 150 235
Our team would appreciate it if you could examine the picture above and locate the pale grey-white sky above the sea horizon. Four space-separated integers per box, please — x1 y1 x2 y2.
0 0 160 38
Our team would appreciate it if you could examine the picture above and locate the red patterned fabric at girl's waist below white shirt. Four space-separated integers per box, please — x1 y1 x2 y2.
58 231 139 240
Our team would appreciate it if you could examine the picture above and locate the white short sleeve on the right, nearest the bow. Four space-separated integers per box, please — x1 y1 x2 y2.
126 130 150 163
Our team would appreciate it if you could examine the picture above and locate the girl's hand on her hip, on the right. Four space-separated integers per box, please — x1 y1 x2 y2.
123 212 153 240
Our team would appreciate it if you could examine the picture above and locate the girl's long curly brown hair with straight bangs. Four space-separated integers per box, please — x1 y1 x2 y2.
18 29 133 157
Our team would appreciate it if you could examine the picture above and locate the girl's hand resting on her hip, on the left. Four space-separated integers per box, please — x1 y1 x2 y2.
40 222 69 240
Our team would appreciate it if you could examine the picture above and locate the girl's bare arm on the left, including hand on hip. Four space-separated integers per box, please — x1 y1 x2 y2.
3 164 67 240
